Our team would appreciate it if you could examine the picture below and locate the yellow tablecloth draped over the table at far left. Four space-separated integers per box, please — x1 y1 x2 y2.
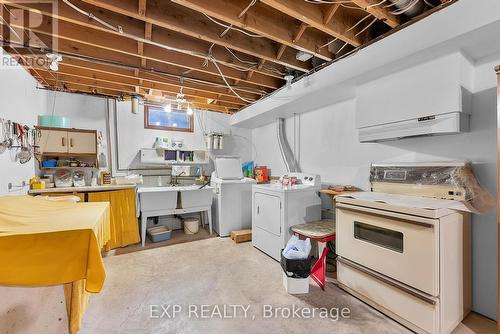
0 196 110 333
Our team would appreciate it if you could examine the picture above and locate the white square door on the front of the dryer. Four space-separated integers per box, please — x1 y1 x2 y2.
253 193 281 236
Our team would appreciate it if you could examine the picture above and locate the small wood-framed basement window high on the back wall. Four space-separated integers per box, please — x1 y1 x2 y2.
144 105 194 132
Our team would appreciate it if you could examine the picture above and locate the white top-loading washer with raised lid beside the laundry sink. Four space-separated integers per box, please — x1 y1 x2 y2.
210 156 257 237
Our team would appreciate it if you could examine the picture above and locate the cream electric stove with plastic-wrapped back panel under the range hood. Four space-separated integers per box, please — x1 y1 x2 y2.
336 165 471 334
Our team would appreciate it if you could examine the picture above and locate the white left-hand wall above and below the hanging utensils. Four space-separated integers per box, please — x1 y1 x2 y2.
0 54 46 196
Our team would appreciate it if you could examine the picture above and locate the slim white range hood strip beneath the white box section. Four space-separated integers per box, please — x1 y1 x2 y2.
359 112 470 143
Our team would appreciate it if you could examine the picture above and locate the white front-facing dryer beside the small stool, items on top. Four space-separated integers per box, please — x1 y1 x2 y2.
252 173 321 261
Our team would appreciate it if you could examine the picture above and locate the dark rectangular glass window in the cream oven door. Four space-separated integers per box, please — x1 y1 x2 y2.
354 221 403 253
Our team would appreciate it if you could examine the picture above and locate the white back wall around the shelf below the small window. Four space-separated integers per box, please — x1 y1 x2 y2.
112 101 252 175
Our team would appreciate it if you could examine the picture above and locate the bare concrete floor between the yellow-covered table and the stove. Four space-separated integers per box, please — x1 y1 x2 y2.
80 238 410 334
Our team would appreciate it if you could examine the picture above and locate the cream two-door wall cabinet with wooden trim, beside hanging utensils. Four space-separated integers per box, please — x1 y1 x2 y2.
36 128 97 155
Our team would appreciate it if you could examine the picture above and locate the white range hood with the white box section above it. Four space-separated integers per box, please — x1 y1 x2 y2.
356 55 472 142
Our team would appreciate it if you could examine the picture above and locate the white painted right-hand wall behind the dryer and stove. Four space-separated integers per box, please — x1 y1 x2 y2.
252 59 500 319
